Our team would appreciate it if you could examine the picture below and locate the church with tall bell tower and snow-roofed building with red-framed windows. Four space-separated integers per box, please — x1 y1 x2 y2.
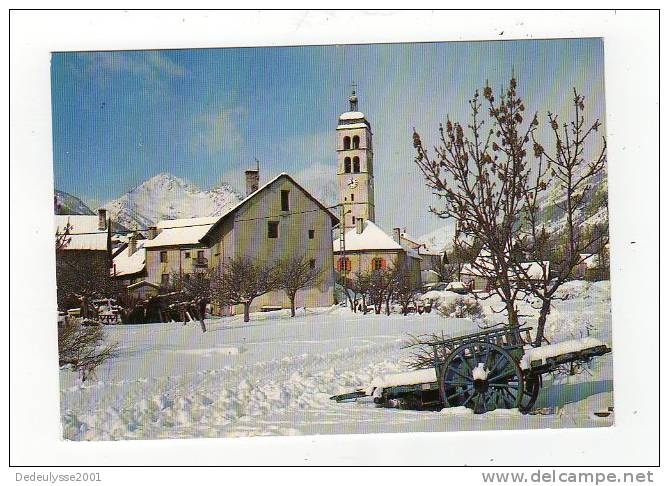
333 90 421 287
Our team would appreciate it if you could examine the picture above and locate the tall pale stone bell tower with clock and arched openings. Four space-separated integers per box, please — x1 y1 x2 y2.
337 87 374 229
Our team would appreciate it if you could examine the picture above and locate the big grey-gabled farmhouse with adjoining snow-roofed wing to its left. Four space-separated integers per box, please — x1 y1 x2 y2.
112 169 339 315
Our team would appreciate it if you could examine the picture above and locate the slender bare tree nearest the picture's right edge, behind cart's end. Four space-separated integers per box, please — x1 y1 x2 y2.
513 89 609 345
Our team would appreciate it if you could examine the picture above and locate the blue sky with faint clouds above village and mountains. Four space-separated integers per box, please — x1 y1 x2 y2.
51 39 604 235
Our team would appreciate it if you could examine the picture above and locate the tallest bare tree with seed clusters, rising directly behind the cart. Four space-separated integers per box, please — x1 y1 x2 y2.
413 78 539 325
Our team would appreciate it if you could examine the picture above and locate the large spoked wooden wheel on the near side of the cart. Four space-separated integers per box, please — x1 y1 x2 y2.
439 342 524 413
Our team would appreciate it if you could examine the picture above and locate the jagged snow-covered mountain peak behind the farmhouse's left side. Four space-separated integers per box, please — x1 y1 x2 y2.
104 173 243 228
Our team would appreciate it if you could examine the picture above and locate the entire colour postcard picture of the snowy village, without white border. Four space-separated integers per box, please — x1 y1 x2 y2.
51 38 615 441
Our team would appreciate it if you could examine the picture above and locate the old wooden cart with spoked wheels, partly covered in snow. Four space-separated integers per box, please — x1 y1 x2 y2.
330 326 611 413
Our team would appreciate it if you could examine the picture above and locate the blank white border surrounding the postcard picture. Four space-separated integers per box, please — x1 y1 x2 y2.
7 11 667 470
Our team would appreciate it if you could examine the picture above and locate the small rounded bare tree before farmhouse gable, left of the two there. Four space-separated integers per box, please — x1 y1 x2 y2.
211 257 278 322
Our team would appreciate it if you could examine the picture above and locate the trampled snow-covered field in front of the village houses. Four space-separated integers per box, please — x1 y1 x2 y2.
60 282 614 440
